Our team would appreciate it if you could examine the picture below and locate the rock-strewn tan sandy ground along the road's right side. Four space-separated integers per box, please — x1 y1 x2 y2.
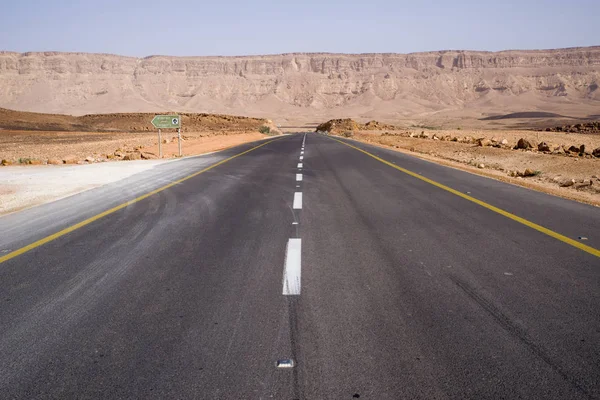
344 130 600 206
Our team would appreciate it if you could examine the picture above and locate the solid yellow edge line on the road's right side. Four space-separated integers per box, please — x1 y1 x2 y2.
330 138 600 257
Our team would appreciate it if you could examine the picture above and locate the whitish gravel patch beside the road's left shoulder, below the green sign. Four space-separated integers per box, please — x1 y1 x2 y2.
0 160 173 215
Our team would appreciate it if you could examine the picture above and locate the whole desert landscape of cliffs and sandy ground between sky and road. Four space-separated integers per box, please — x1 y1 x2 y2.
0 46 600 209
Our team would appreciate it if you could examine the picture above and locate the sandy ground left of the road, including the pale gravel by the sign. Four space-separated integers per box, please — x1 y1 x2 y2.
0 132 270 215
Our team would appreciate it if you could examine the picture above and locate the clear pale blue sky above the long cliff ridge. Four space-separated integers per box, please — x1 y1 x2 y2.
0 0 600 57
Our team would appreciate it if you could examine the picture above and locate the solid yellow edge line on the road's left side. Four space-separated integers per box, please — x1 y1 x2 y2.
0 138 281 264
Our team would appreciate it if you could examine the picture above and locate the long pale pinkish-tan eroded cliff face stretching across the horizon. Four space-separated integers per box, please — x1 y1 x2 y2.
0 47 600 116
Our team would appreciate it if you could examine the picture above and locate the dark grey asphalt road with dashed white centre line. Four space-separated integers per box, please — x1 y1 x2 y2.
0 133 600 399
